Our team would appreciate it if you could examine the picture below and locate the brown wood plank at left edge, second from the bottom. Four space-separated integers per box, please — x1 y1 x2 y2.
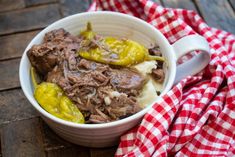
0 89 38 125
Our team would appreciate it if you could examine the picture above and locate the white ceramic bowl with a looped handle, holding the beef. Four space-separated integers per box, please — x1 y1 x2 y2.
19 12 210 147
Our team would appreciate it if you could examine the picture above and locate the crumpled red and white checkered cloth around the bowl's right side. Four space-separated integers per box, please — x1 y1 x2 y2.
89 0 235 157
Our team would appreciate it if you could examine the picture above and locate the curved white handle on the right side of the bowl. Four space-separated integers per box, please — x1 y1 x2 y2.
172 35 211 84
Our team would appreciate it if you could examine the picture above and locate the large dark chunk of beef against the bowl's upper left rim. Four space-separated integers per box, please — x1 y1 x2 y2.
27 29 79 76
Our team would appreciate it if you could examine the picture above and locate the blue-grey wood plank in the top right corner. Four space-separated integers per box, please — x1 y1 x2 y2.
195 0 235 34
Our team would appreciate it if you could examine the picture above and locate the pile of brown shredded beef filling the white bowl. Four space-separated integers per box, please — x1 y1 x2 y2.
27 29 145 123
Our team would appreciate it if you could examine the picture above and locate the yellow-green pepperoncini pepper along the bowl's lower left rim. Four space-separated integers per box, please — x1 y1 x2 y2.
31 68 85 123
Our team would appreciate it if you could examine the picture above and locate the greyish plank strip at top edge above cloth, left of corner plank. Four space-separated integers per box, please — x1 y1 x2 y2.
162 0 197 11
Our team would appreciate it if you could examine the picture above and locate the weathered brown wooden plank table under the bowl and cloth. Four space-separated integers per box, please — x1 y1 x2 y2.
0 0 235 157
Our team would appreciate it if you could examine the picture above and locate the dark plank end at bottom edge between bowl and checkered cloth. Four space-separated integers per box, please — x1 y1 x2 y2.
90 147 117 157
